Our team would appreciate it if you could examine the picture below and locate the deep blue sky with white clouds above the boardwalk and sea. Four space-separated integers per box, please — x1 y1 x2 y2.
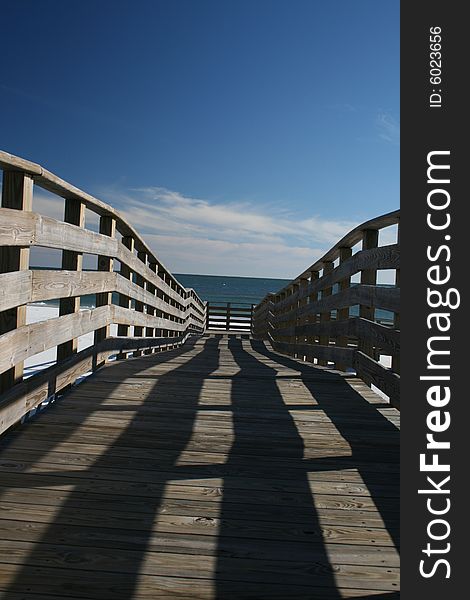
0 0 399 277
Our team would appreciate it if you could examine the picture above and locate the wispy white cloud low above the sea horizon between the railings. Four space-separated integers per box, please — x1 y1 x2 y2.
30 186 356 278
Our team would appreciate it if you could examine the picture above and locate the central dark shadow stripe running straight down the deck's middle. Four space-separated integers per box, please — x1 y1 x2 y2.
216 339 341 599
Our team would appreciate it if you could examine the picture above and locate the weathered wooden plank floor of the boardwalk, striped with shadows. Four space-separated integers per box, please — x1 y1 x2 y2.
0 335 399 600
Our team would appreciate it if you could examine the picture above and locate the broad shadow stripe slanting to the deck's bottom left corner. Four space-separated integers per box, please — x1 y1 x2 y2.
1 338 219 600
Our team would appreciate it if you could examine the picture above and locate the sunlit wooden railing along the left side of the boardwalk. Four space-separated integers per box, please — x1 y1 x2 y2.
0 151 206 433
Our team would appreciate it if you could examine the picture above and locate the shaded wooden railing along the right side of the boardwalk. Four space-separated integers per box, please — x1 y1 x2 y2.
253 211 400 408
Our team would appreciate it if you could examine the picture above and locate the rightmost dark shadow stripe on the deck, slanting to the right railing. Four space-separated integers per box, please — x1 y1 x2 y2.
251 340 400 550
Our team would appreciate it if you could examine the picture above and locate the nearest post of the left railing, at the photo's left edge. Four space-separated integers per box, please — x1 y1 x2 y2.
0 171 33 393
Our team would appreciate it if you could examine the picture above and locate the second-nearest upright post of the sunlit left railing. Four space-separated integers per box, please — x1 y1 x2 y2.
57 198 85 362
